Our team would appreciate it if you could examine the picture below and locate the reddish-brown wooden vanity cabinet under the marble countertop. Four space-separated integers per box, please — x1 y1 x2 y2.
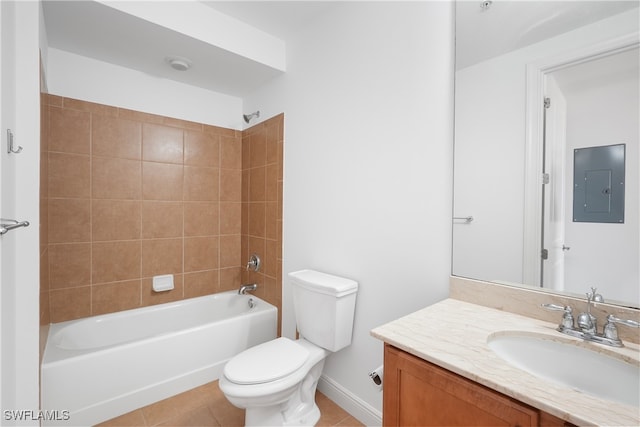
382 344 571 427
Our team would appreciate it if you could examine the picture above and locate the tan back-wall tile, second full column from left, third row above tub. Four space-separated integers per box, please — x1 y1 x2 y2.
91 200 141 242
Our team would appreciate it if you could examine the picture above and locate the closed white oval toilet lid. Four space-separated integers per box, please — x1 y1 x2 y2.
224 337 309 384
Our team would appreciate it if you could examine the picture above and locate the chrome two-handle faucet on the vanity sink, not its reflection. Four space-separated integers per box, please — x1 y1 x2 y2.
542 288 640 347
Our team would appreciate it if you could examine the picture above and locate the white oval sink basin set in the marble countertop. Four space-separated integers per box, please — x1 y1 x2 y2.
487 332 640 407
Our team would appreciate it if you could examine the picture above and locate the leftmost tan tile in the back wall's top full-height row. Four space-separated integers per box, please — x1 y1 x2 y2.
49 107 91 154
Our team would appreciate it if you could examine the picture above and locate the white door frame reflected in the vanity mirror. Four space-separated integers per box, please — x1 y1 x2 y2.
522 31 640 284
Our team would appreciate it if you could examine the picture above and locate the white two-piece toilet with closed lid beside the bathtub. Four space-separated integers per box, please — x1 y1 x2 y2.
219 270 358 426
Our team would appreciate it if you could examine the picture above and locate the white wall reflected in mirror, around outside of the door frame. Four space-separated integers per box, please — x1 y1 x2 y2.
453 9 638 283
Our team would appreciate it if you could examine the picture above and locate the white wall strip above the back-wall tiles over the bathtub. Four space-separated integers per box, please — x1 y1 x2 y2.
47 48 244 129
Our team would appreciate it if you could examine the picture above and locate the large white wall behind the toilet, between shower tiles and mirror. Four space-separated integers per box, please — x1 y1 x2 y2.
245 2 453 425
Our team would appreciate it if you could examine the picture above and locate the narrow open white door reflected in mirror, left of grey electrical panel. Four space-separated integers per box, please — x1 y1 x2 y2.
541 74 567 291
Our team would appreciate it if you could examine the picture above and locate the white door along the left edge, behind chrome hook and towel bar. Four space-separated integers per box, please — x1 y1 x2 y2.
0 1 40 425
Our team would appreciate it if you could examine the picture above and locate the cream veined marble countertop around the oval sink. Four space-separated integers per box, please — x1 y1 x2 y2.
371 299 640 426
